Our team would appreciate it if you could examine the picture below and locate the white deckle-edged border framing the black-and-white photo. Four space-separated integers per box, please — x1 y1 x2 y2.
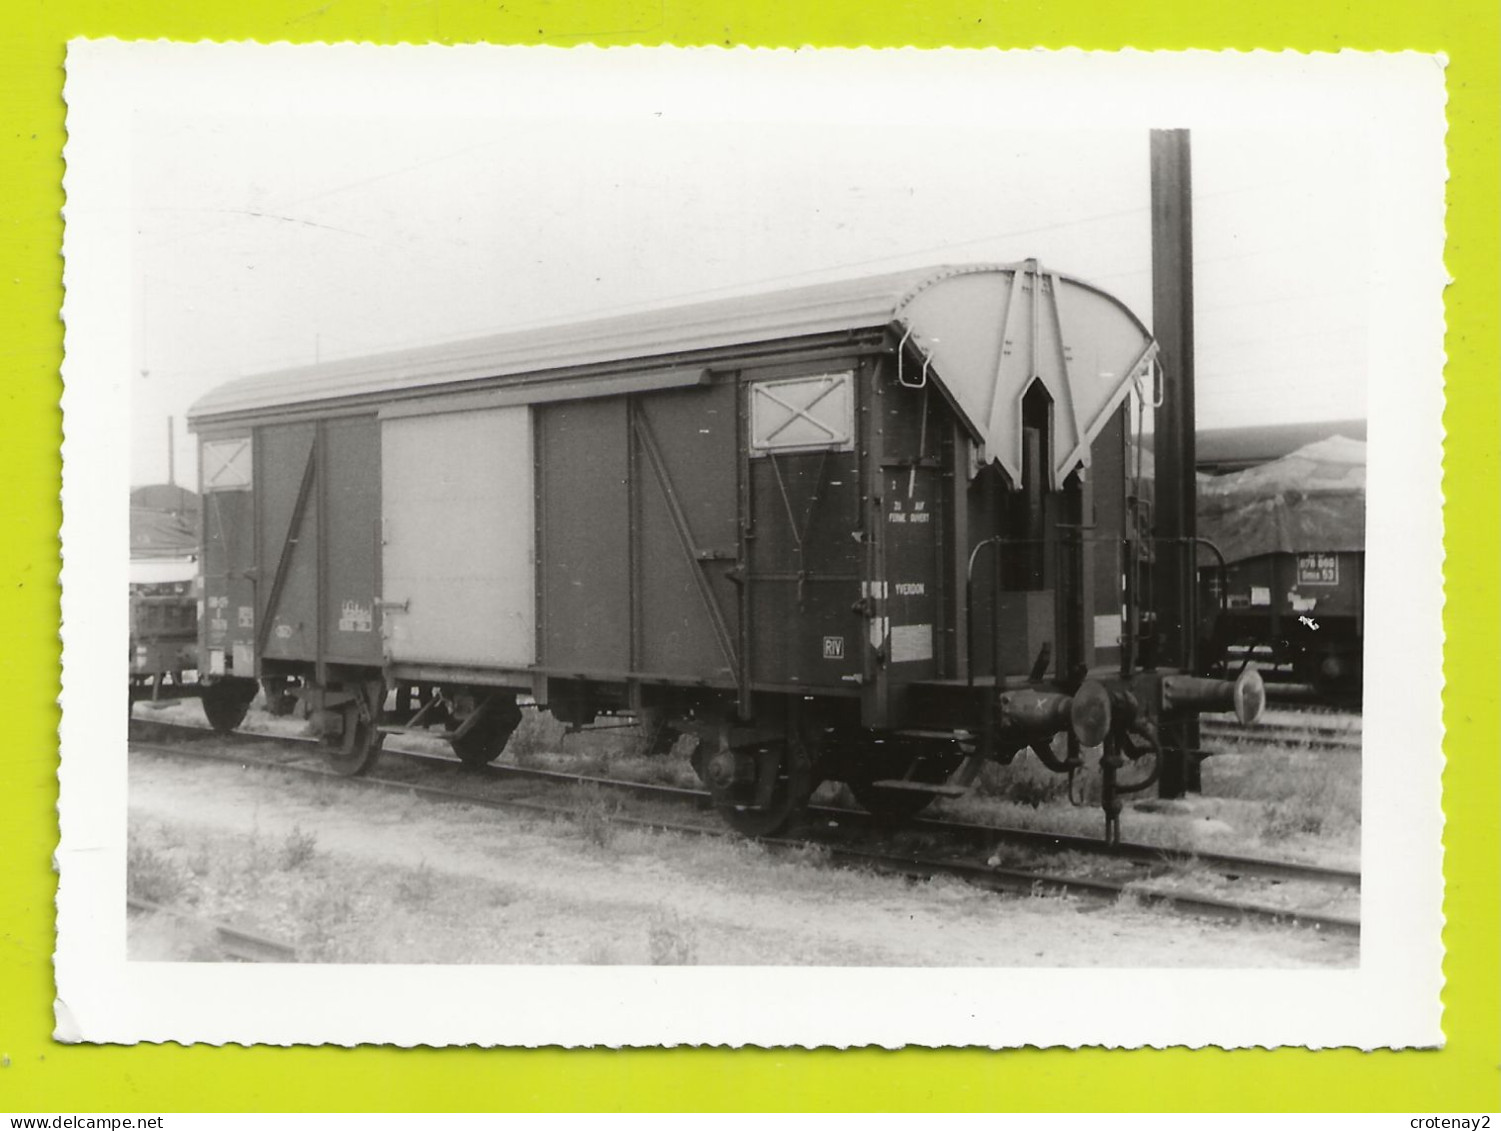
56 41 1447 1048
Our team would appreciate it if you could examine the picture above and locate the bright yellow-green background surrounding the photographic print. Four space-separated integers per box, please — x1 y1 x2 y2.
0 0 1501 1113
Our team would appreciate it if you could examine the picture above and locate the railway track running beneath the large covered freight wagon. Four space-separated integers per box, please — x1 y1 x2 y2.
131 721 1360 934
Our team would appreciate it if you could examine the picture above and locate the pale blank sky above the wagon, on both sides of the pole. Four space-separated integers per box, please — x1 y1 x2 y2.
120 48 1372 485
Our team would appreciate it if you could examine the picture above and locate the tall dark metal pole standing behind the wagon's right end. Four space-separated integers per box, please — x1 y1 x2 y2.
1151 129 1199 798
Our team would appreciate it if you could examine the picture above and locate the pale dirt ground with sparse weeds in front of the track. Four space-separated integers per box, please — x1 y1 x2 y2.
129 752 1358 967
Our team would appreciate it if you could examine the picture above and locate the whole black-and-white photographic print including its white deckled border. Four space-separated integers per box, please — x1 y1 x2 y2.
57 42 1447 1048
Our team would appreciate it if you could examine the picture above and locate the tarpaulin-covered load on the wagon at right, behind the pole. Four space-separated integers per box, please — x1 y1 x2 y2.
1198 436 1366 565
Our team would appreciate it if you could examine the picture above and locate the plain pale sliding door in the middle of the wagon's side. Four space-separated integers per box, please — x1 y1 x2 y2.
381 406 536 670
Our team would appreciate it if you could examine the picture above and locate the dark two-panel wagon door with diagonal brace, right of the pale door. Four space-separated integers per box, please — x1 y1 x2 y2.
537 382 740 686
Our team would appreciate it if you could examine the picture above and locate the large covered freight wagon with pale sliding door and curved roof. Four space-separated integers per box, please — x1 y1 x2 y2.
191 261 1259 834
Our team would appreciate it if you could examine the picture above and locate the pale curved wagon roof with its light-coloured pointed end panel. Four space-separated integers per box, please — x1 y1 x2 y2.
189 260 1151 475
